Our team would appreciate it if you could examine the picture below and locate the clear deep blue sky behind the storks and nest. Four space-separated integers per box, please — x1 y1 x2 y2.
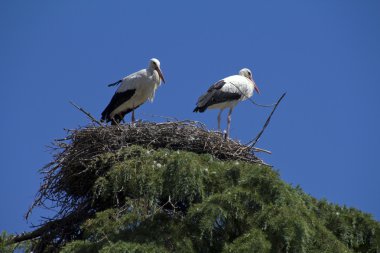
0 0 380 232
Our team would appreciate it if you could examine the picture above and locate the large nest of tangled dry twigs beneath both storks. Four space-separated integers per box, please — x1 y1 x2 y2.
27 121 263 217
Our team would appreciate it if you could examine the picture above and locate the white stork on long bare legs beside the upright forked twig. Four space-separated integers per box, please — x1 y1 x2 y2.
193 68 260 136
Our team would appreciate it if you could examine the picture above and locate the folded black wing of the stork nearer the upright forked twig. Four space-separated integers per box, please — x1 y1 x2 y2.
193 80 241 112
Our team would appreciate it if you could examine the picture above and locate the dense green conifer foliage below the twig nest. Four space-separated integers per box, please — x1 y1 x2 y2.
42 146 380 253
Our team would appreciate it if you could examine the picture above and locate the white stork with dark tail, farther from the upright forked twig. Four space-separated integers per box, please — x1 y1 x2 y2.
101 58 165 125
